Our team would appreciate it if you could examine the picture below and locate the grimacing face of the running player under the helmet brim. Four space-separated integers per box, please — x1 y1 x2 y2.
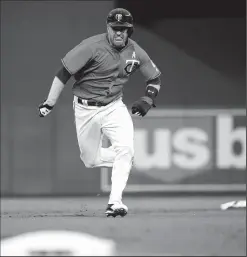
107 26 128 48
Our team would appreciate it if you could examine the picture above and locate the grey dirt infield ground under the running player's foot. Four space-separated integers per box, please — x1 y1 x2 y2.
1 196 246 256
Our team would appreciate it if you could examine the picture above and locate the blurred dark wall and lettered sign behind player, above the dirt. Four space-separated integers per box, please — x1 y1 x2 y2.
1 0 246 196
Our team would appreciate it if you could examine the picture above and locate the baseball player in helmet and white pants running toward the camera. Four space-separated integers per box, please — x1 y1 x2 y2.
39 8 161 217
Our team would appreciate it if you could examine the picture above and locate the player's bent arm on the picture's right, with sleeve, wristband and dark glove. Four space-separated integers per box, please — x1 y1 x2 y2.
132 48 161 116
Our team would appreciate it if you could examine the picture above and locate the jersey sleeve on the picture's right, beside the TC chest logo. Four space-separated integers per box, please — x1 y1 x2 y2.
137 44 161 81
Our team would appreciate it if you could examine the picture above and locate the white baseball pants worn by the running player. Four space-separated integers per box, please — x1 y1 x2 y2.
73 96 134 204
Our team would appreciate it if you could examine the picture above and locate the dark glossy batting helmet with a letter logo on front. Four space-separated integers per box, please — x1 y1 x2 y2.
106 8 134 37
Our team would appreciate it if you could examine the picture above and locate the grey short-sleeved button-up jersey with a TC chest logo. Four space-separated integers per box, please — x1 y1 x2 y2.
62 33 160 103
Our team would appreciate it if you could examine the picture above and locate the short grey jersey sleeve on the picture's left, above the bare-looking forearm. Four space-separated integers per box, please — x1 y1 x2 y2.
61 42 93 75
